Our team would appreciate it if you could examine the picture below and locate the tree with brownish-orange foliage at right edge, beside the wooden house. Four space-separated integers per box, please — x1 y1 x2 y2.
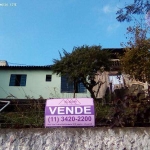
121 26 150 81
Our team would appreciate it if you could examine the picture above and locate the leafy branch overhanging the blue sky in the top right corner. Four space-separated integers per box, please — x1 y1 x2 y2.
116 0 150 22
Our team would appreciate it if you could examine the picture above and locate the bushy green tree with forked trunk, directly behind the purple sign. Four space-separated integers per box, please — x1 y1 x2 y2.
52 46 110 99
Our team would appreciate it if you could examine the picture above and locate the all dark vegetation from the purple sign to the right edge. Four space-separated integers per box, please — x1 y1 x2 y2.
95 88 150 127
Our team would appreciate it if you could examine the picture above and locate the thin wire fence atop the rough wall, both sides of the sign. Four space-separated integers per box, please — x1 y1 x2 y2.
0 99 150 128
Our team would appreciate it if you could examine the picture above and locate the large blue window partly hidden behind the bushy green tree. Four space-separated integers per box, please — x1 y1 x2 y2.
61 76 87 93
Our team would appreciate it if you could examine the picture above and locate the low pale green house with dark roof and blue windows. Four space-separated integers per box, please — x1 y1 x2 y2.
0 61 90 99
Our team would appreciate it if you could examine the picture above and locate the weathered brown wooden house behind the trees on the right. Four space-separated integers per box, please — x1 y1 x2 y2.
93 48 148 98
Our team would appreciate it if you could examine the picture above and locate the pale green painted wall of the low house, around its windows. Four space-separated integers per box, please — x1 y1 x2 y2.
0 70 90 99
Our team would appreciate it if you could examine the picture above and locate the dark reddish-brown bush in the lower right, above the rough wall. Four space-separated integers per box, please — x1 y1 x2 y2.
111 89 150 127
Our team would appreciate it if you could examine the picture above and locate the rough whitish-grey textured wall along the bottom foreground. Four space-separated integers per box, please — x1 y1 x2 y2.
0 128 150 150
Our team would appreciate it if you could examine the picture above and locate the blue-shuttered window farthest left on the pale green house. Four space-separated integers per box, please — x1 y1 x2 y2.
9 74 27 86
